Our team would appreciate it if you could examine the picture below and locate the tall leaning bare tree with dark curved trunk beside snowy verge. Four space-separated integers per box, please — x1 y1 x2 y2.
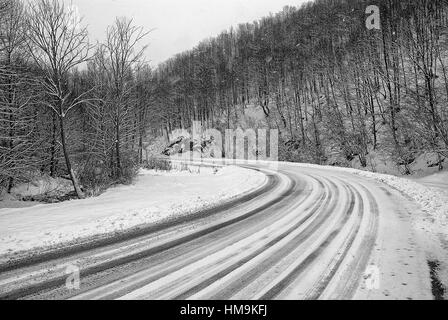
27 0 91 198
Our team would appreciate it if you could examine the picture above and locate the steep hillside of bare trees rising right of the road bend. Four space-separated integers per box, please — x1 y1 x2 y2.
155 0 448 173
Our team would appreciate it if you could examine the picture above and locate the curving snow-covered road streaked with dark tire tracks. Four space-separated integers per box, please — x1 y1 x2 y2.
0 164 432 299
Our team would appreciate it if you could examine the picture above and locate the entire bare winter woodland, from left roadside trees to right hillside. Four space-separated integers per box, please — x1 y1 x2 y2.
0 0 448 198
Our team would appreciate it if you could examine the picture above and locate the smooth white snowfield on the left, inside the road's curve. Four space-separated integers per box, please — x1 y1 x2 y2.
0 167 267 256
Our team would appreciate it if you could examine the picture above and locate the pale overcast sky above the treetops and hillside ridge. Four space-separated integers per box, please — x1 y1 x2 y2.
65 0 307 66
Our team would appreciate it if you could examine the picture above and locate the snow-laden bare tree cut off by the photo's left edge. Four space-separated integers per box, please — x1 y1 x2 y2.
0 0 39 192
